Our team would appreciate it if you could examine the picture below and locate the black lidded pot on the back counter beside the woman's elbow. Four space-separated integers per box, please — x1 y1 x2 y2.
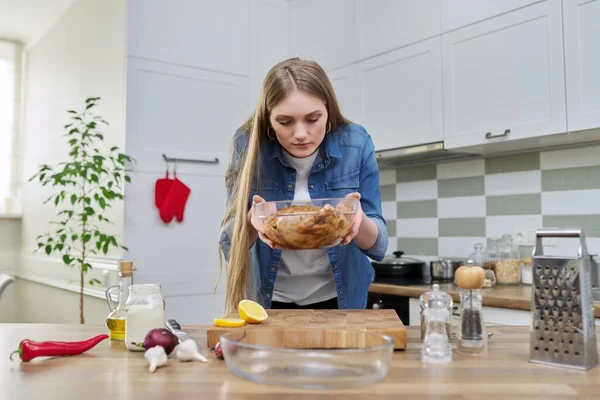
371 251 431 285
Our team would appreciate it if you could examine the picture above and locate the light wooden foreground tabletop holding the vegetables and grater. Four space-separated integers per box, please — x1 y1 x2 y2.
0 324 600 400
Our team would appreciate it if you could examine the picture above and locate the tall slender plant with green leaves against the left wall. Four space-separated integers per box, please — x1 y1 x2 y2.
29 97 132 324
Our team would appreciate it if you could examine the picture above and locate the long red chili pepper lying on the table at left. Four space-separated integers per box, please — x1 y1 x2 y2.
10 334 108 362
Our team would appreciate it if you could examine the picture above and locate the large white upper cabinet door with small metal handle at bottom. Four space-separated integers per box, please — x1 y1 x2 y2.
442 0 567 148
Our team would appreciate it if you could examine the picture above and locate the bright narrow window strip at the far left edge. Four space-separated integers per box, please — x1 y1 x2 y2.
0 41 20 205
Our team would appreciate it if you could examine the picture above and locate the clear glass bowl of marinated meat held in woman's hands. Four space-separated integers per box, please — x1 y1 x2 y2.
255 198 359 250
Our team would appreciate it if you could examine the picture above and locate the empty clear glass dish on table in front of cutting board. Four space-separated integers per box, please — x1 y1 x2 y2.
220 328 394 389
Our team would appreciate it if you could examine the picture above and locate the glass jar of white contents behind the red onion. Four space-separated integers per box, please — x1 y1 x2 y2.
125 284 165 351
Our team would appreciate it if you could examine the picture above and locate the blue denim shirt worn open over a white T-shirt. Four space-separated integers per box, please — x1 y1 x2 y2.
219 123 388 309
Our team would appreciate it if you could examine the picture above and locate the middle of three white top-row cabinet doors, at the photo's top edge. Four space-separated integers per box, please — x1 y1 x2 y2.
355 0 440 59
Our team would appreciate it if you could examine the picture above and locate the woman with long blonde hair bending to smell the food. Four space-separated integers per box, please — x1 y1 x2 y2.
219 58 388 312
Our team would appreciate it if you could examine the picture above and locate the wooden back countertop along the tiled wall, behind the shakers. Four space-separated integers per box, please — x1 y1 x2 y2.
369 283 600 318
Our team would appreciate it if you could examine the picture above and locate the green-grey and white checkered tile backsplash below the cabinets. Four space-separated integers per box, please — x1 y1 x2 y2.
381 146 600 257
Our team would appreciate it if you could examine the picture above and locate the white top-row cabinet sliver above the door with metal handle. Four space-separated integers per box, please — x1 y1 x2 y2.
441 0 540 32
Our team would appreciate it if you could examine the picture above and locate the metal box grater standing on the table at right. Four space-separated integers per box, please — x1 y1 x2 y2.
529 229 598 370
